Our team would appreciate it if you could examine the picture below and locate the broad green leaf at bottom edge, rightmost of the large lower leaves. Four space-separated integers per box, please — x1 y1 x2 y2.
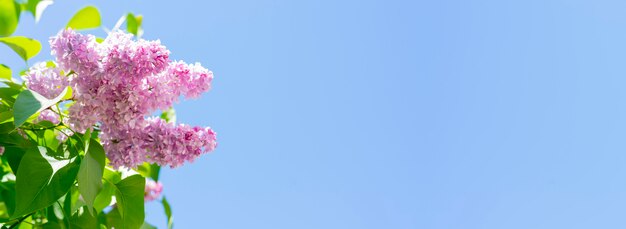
114 175 146 229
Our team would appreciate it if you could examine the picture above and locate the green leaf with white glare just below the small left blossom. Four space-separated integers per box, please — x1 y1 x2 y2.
13 87 68 127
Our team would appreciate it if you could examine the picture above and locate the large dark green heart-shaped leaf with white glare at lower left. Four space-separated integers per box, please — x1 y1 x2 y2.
11 146 79 219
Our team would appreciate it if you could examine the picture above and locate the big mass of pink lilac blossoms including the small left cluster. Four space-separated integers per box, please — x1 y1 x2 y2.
27 29 216 168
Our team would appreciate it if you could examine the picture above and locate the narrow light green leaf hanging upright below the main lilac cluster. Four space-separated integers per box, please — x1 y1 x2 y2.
76 139 105 214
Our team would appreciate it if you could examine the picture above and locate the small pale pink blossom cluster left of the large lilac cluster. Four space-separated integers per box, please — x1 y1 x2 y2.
24 62 69 99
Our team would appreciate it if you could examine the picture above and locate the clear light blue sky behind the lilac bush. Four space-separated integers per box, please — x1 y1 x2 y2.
0 0 626 229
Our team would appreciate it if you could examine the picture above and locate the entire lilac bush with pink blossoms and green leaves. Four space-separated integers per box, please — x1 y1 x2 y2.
0 3 217 228
